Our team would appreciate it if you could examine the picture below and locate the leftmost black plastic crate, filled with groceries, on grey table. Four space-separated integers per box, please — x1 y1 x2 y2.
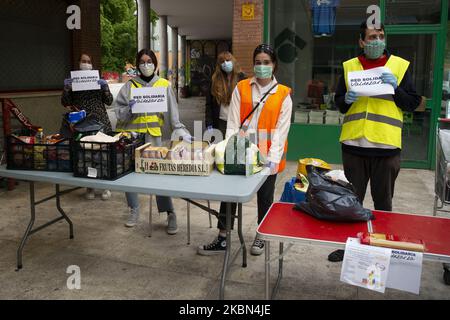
6 135 73 172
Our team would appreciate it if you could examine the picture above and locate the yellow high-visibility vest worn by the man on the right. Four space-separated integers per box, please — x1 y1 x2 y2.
339 55 409 148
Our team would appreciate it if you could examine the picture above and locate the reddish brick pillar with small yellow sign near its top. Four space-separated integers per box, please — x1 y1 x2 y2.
233 0 264 76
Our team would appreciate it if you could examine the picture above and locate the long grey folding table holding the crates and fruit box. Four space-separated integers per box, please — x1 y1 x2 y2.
0 166 268 299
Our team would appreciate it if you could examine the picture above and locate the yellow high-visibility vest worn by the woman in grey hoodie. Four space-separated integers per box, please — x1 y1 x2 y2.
116 78 170 137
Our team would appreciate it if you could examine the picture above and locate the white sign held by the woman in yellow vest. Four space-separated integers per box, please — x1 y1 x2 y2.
131 87 167 113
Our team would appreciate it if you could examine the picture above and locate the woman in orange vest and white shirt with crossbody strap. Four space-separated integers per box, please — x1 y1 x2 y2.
197 44 292 255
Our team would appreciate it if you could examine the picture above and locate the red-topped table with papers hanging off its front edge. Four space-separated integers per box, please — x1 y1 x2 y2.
257 202 450 299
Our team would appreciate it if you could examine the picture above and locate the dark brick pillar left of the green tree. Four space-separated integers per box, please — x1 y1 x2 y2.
72 0 101 70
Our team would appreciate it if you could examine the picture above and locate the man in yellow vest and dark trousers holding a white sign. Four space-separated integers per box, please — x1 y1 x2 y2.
328 22 421 262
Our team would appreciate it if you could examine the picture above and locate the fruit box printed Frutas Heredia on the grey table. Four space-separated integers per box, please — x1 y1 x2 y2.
135 142 216 176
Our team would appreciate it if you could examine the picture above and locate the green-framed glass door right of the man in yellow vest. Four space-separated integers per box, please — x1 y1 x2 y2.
381 0 448 169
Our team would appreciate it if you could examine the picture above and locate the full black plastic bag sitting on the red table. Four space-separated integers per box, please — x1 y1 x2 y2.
294 166 375 222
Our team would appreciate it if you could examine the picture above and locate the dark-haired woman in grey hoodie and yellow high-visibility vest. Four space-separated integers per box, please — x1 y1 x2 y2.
116 49 192 234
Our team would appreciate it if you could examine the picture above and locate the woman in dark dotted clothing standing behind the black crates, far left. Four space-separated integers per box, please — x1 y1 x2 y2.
61 53 113 200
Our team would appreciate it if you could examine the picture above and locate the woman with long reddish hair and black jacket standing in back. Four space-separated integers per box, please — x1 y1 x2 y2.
205 51 245 137
